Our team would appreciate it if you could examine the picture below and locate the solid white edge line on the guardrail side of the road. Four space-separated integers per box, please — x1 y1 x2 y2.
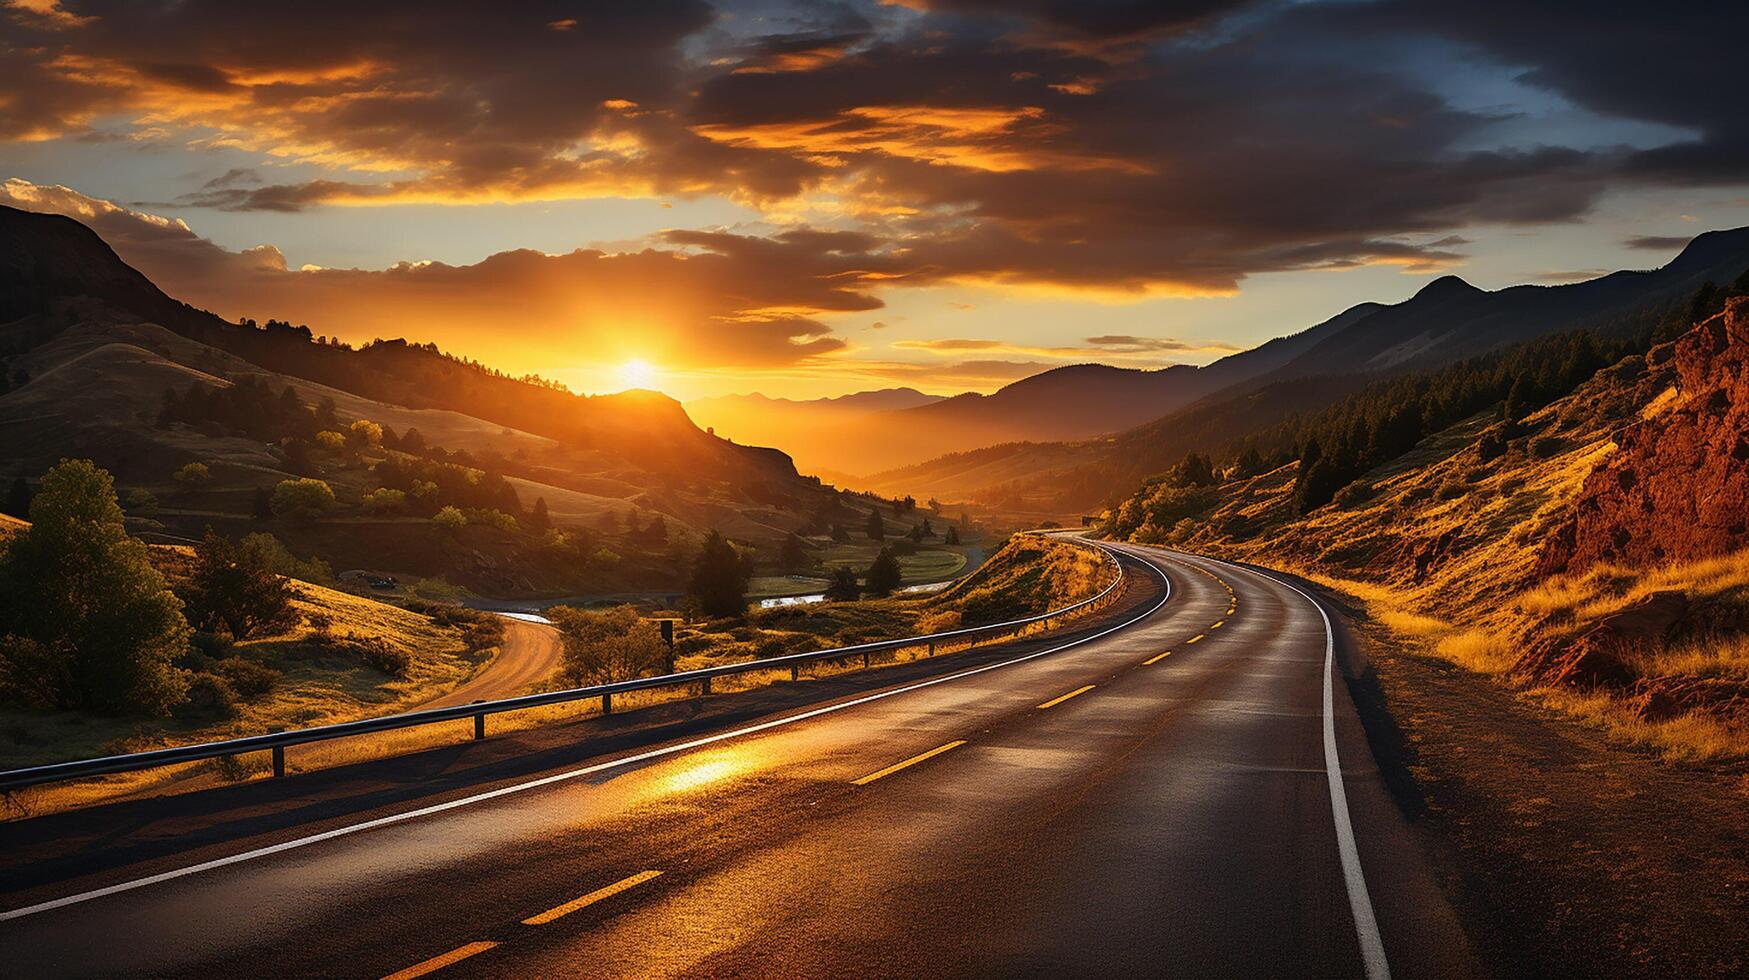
0 555 1172 922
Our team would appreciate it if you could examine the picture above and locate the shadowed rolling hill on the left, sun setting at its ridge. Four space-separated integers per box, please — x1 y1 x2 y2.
0 208 850 593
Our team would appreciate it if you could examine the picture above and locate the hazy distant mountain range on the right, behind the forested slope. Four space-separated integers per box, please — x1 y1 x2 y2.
857 228 1749 513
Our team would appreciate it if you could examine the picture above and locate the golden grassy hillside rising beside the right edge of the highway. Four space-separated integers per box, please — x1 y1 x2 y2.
1109 325 1749 760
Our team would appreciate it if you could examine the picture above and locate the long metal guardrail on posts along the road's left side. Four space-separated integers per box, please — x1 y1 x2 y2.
0 532 1123 791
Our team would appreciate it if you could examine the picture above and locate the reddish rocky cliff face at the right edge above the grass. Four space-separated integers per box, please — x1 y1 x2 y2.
1537 298 1749 574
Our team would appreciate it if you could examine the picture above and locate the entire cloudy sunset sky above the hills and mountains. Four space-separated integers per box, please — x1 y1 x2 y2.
0 0 1749 397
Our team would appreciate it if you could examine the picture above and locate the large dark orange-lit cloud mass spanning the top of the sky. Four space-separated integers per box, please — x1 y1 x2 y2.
0 0 1749 302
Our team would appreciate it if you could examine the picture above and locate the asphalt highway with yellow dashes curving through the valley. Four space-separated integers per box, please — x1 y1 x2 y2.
0 550 1478 977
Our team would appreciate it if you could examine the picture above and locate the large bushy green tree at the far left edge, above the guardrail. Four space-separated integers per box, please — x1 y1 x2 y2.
0 460 189 714
